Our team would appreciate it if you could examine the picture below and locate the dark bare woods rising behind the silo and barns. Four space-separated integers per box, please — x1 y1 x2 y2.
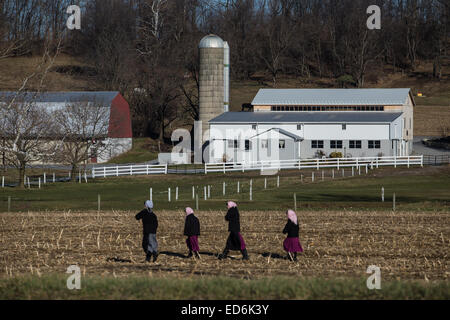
0 0 450 139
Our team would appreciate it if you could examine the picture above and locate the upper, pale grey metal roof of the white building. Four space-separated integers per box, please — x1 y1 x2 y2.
252 88 414 106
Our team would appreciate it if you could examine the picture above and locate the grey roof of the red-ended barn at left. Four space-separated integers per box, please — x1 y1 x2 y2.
0 91 119 105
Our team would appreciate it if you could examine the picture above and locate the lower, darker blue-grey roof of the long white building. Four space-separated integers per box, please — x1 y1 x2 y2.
209 111 402 123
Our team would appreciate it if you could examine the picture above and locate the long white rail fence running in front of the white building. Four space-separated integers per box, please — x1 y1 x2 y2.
205 155 423 174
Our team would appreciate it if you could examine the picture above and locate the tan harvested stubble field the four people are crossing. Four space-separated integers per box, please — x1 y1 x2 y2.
0 211 450 280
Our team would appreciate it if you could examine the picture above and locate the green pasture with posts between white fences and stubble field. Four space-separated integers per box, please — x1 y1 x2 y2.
0 167 450 212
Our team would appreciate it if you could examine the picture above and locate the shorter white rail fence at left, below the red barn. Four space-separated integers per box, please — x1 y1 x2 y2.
92 164 167 178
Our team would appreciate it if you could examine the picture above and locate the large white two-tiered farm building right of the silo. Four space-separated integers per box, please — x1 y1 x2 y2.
209 89 414 162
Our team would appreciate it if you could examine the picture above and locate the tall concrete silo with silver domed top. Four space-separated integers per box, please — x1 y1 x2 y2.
199 34 225 145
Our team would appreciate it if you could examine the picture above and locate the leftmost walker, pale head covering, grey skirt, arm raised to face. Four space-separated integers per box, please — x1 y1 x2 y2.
136 200 158 262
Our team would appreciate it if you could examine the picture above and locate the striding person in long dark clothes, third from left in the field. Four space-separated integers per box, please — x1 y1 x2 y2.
219 201 248 260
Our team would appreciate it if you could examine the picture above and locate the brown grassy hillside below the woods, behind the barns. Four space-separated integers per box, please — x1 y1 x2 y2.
0 55 450 141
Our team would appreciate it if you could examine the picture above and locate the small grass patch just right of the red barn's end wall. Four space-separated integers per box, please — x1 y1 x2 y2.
108 138 158 164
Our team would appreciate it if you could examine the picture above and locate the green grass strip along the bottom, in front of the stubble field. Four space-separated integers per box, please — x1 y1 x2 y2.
0 275 450 300
